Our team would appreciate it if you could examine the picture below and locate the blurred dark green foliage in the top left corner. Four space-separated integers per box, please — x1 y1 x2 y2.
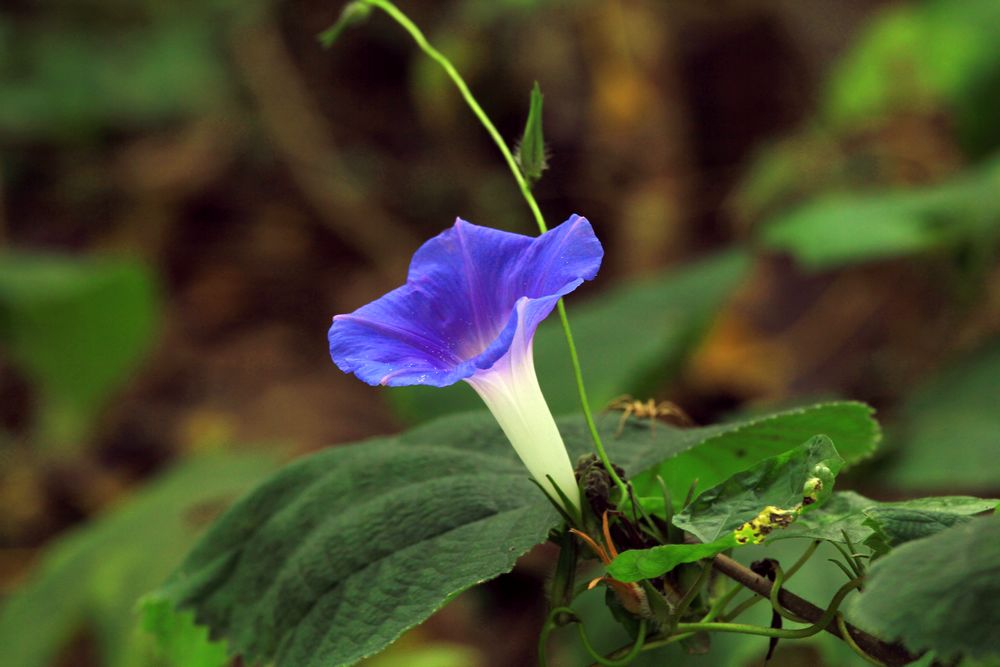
0 20 227 140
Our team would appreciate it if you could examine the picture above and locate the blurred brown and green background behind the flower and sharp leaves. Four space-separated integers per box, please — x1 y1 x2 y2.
0 0 1000 667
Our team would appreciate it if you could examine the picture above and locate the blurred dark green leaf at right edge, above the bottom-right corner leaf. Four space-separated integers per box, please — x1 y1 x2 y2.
881 340 1000 492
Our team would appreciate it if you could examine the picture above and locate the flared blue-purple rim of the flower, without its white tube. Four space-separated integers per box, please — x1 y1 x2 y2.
329 215 604 387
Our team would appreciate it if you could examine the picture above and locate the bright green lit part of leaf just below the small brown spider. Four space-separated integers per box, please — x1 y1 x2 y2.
626 401 881 502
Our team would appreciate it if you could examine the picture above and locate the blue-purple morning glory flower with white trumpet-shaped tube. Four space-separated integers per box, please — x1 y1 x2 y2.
329 215 604 508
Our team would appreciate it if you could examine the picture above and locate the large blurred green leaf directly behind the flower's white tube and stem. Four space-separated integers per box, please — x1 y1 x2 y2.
388 252 749 422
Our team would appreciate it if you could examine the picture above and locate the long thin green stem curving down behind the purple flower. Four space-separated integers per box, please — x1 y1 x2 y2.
360 0 628 501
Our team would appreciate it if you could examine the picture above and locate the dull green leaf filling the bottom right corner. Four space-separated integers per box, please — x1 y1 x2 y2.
848 516 1000 662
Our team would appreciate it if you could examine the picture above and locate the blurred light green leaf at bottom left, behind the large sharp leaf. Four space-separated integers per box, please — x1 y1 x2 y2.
0 455 274 667
